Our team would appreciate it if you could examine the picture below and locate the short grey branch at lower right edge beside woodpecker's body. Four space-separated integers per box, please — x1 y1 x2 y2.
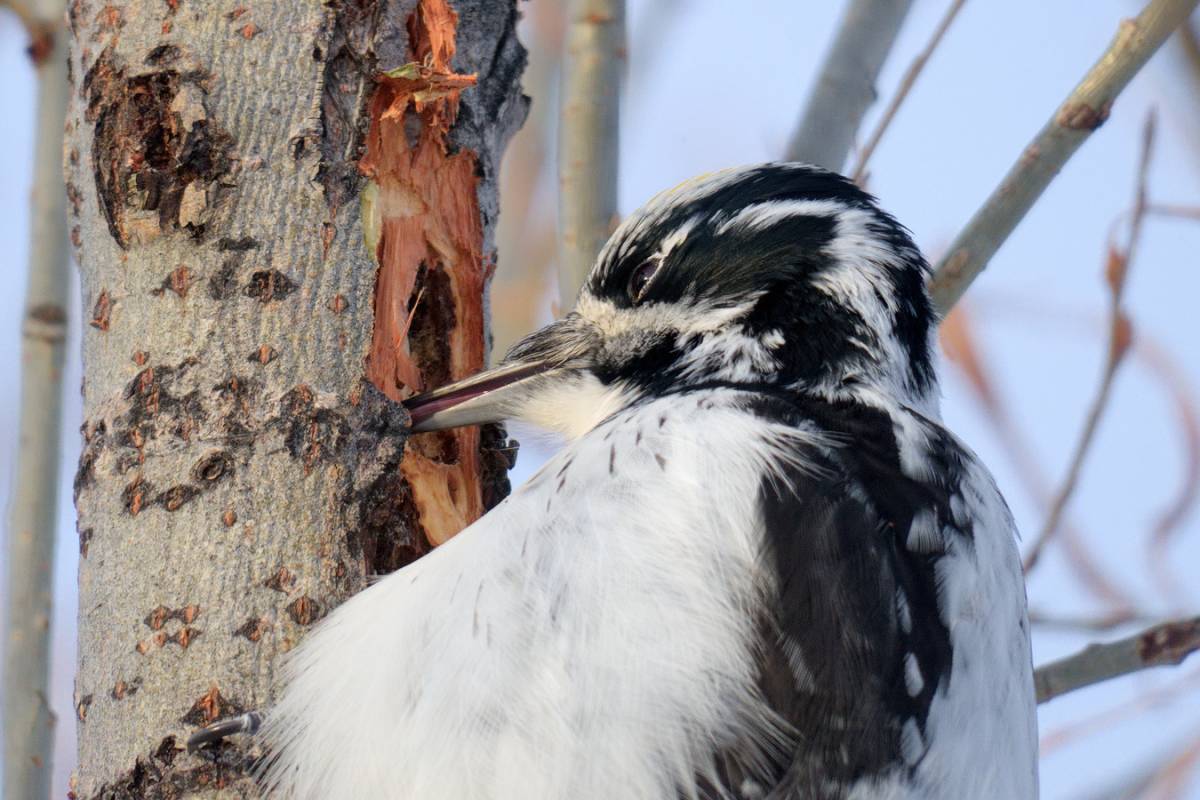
1033 616 1200 703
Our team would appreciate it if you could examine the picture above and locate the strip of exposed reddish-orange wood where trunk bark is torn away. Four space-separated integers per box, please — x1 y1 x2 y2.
359 0 488 545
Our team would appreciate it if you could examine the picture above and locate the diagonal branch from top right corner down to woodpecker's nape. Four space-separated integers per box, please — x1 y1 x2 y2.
930 0 1200 312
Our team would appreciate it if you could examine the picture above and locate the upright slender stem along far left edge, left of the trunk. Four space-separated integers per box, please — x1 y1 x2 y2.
4 4 70 798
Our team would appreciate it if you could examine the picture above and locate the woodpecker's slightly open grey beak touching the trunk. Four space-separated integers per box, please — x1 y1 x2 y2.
404 314 596 433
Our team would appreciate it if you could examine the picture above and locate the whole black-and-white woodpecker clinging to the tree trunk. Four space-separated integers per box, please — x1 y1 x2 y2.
192 163 1038 800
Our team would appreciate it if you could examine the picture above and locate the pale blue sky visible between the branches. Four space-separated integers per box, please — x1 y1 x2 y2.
0 0 1200 799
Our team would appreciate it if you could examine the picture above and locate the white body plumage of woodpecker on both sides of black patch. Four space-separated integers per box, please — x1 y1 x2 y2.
263 390 1037 800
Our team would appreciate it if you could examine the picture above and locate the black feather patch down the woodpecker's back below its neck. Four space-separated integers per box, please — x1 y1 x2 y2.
686 396 971 800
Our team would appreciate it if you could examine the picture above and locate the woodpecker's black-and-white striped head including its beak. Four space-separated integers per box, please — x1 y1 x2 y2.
406 163 936 438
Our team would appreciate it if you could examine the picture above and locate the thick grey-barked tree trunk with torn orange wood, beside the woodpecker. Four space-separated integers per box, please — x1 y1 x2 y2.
67 0 527 798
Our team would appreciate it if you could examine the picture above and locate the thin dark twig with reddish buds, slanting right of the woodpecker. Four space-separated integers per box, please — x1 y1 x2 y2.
1025 113 1154 573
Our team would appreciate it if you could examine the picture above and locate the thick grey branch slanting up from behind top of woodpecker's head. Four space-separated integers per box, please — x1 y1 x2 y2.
787 0 912 170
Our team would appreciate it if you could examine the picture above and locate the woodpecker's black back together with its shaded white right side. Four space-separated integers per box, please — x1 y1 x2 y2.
702 398 1036 800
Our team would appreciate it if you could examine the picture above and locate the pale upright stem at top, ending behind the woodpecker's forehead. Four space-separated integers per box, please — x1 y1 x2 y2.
558 0 625 309
